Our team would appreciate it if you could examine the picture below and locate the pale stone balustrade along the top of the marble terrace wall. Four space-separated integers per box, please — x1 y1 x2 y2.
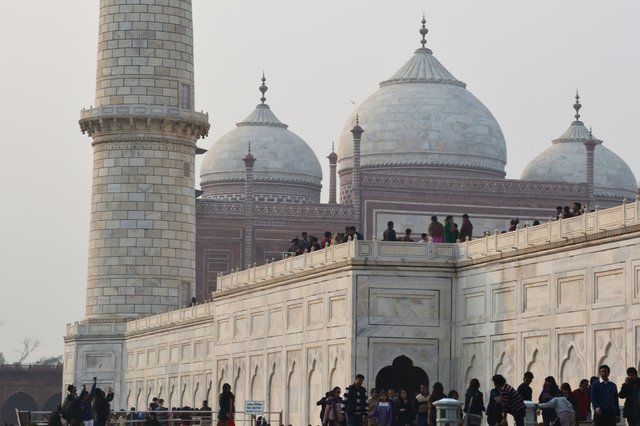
216 199 640 292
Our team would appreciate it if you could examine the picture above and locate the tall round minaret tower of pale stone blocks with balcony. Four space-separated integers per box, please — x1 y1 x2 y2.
80 0 209 320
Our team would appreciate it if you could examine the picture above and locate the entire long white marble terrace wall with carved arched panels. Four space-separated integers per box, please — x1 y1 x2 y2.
65 211 640 425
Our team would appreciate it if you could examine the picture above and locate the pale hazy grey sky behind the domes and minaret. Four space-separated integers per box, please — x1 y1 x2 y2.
0 0 640 361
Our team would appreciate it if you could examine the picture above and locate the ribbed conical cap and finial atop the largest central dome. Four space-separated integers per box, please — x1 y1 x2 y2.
380 16 467 87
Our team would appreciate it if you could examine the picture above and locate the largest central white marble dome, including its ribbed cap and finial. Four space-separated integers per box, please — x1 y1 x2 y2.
338 20 507 178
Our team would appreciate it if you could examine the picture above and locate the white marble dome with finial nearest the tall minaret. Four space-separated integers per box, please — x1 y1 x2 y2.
200 75 322 203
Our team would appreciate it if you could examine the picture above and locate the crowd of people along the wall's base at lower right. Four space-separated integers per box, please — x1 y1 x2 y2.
317 365 640 426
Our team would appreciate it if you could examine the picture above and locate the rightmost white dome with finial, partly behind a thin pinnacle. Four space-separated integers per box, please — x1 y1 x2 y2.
521 93 638 201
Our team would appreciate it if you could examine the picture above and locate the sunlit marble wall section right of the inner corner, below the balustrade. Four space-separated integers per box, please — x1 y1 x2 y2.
454 236 640 400
